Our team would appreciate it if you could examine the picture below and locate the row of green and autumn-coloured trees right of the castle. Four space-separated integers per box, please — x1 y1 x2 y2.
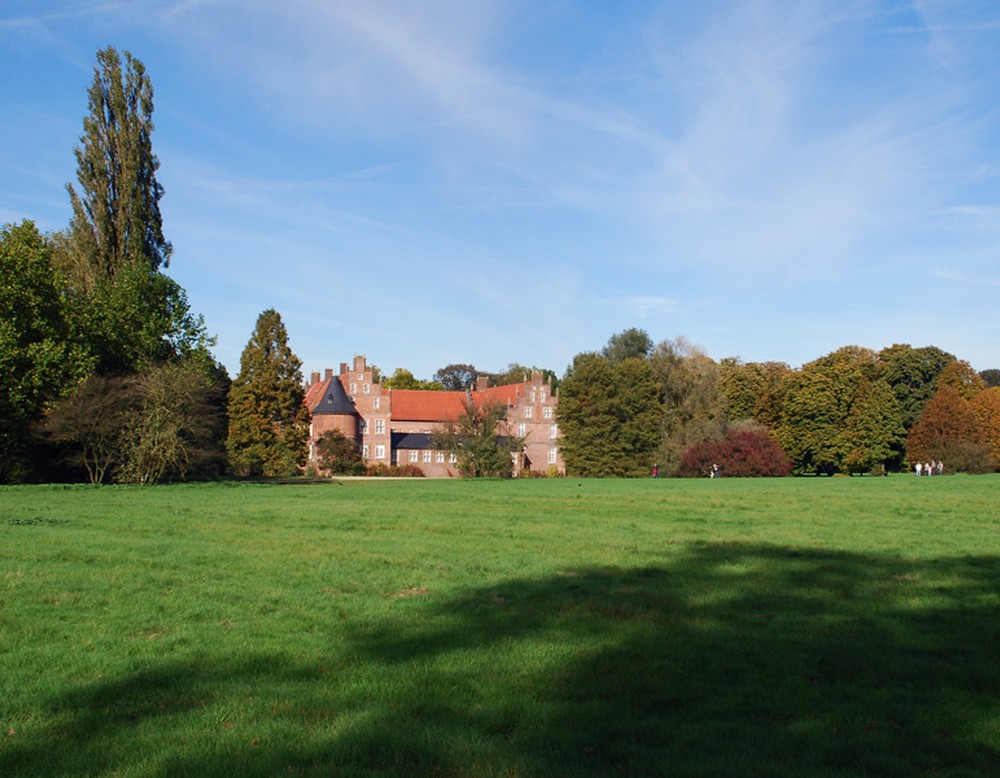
557 329 1000 476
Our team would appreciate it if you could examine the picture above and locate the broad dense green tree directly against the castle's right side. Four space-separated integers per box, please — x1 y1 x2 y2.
556 353 662 477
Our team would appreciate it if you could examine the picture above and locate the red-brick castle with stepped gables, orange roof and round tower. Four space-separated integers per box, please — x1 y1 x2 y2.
305 355 566 477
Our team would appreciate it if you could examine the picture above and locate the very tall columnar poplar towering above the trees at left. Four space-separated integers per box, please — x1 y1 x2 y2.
53 47 212 374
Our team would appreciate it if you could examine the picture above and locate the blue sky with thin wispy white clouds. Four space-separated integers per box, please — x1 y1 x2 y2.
0 0 1000 378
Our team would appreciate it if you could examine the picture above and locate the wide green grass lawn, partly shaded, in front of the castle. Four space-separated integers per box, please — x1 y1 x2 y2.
0 475 1000 777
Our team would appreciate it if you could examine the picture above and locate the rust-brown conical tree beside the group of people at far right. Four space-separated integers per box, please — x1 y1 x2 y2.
906 384 996 473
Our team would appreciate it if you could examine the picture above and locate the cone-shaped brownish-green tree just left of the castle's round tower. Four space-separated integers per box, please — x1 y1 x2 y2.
226 309 309 477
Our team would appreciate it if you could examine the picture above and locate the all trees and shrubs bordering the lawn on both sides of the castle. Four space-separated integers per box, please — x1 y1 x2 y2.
0 47 1000 484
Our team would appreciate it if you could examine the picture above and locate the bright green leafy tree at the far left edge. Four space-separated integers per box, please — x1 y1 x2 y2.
0 220 89 482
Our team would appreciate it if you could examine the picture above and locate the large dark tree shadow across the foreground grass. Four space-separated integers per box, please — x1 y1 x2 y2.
0 544 1000 776
